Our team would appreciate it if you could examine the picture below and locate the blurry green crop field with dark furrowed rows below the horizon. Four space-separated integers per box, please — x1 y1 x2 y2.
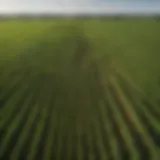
0 19 160 160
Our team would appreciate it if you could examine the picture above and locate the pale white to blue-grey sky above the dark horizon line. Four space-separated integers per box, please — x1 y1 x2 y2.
0 0 160 14
